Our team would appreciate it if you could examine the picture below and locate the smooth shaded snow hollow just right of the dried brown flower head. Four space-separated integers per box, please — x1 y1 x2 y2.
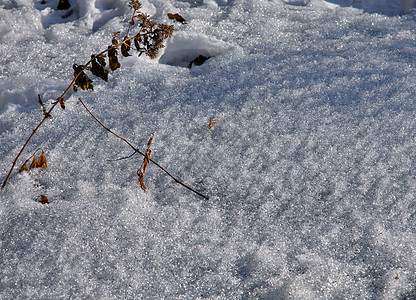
159 32 231 67
